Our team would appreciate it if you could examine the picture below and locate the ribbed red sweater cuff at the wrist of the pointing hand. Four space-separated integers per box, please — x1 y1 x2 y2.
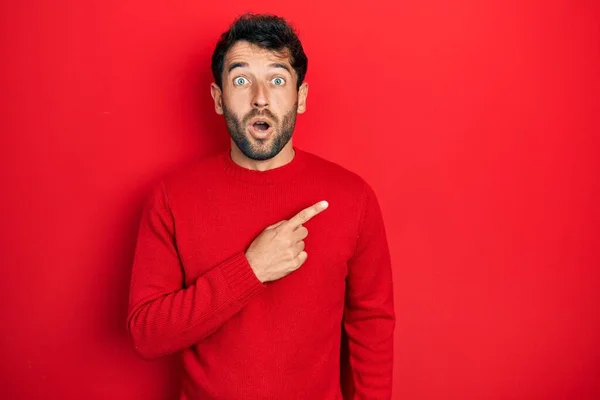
221 252 264 302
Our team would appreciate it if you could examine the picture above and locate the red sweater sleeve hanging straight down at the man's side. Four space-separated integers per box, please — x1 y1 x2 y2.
344 183 395 400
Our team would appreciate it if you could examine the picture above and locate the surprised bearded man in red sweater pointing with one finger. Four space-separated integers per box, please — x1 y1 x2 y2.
128 15 395 400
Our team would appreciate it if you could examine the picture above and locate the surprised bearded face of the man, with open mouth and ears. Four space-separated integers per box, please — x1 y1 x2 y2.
211 41 308 160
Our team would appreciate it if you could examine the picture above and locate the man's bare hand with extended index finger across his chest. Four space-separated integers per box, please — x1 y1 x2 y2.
246 201 328 283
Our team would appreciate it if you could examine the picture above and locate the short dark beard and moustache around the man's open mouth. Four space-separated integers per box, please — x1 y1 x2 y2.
223 102 298 161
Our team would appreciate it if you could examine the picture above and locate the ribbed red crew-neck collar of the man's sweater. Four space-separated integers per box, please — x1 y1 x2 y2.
221 146 306 185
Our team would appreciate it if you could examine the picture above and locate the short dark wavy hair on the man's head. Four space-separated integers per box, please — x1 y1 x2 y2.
212 13 308 89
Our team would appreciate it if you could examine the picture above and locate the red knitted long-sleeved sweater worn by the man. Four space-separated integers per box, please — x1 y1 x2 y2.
128 147 395 400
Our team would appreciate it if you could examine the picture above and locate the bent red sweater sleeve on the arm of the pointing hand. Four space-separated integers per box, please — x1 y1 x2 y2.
127 183 264 359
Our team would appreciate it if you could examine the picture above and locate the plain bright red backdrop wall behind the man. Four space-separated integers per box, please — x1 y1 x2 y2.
0 0 600 400
